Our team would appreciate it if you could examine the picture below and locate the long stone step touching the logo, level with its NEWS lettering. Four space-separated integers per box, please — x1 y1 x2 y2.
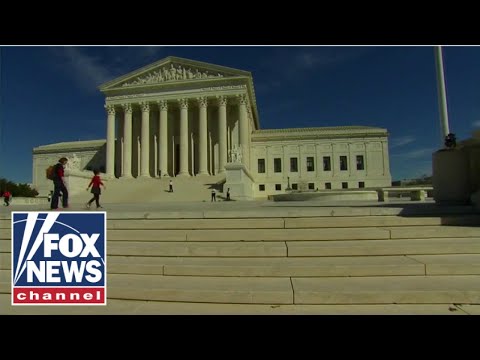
108 256 425 277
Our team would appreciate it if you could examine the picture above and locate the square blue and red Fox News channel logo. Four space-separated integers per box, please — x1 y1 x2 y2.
12 211 107 305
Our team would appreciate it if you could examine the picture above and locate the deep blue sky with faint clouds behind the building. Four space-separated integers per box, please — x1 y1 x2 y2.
0 46 480 183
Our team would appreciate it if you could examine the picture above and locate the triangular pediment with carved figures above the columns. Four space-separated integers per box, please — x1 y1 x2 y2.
99 56 251 91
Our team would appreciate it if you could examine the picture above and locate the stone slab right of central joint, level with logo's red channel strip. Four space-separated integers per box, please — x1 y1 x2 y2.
292 275 480 304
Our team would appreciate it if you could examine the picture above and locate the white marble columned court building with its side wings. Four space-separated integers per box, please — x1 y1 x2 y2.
33 57 391 198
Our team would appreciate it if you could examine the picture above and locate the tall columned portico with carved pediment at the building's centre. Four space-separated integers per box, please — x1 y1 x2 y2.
100 57 258 178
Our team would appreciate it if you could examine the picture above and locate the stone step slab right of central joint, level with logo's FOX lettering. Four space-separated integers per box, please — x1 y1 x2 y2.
286 238 480 256
